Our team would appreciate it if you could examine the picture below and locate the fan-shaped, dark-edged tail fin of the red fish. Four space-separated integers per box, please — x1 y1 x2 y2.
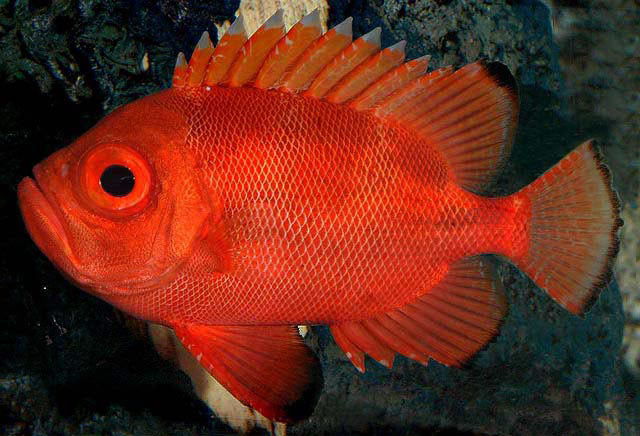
515 141 622 314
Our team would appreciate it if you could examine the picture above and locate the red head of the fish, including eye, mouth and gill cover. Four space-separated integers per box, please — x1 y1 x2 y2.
18 91 211 300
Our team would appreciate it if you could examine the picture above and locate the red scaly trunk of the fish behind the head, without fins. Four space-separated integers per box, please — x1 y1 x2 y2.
87 87 529 325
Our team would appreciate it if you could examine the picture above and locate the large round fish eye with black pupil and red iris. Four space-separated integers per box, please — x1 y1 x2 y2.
77 144 153 217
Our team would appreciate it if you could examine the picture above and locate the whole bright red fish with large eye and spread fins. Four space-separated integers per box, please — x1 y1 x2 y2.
18 10 622 423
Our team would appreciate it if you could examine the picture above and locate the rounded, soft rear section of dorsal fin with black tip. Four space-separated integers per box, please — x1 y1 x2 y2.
384 62 518 192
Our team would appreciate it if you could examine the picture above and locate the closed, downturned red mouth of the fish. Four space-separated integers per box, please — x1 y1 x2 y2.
18 168 77 276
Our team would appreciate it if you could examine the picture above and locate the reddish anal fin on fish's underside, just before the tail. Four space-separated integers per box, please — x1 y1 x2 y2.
331 257 507 372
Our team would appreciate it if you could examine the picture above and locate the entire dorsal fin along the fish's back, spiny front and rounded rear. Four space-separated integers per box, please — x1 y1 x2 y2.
173 14 518 192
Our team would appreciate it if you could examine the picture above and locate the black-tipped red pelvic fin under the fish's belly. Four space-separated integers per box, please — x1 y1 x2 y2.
172 324 322 422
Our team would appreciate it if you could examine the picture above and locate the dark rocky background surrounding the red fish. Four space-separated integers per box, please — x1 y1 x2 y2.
0 0 640 435
